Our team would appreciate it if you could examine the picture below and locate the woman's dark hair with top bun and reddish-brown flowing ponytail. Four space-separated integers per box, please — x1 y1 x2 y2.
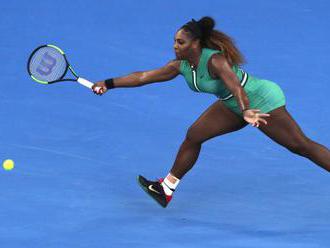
180 16 245 65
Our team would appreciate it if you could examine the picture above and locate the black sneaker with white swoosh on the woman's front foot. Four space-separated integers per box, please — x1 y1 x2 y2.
137 176 172 208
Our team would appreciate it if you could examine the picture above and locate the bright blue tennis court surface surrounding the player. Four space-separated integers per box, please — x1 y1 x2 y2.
0 0 330 248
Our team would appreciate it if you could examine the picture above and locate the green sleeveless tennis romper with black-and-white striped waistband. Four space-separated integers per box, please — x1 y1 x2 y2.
180 48 285 116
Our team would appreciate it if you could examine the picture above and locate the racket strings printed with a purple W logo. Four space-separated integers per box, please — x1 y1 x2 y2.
29 46 67 82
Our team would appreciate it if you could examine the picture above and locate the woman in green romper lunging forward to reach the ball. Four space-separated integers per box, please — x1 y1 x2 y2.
93 17 330 207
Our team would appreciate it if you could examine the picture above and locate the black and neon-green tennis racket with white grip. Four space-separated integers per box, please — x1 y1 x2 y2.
27 45 98 89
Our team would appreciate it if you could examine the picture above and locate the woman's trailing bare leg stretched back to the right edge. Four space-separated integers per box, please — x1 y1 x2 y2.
259 106 330 172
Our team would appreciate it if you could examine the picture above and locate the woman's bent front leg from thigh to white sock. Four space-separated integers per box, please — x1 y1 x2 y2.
170 101 247 179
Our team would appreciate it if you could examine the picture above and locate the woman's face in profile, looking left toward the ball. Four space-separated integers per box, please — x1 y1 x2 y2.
173 29 194 60
